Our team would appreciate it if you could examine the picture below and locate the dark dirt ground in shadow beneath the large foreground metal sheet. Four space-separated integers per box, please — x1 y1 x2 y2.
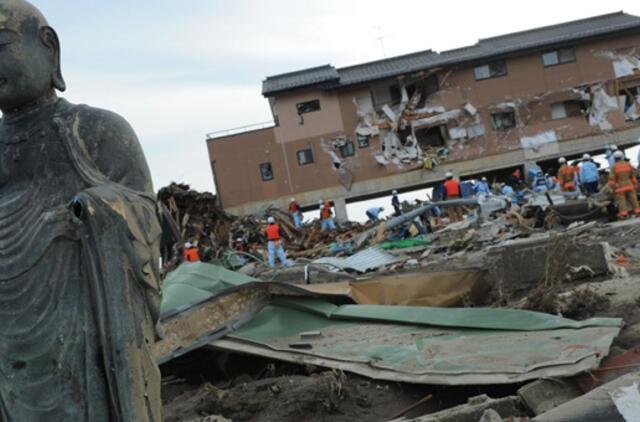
163 371 438 422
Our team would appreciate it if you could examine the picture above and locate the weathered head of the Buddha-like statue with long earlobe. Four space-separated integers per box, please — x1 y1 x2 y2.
0 0 66 113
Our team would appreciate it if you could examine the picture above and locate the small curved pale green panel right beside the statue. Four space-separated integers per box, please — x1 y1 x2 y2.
160 262 256 314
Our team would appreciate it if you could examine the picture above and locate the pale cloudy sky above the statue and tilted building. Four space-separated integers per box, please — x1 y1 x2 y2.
33 0 640 198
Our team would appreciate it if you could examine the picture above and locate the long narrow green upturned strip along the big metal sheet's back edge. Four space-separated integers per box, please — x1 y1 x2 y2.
273 298 622 331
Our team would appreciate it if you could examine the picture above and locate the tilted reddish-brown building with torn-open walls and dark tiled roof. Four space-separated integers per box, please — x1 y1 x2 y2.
207 12 640 219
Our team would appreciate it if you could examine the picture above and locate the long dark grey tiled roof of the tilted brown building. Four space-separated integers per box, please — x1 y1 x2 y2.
262 11 640 96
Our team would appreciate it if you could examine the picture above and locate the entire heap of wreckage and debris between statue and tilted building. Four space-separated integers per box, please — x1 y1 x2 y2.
155 183 640 422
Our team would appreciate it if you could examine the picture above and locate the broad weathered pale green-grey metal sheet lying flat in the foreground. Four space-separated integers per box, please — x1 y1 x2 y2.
210 305 621 385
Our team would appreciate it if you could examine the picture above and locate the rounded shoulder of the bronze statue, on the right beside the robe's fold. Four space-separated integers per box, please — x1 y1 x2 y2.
74 105 153 193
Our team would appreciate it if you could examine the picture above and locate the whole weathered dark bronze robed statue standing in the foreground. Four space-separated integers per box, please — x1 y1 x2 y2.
0 0 161 422
